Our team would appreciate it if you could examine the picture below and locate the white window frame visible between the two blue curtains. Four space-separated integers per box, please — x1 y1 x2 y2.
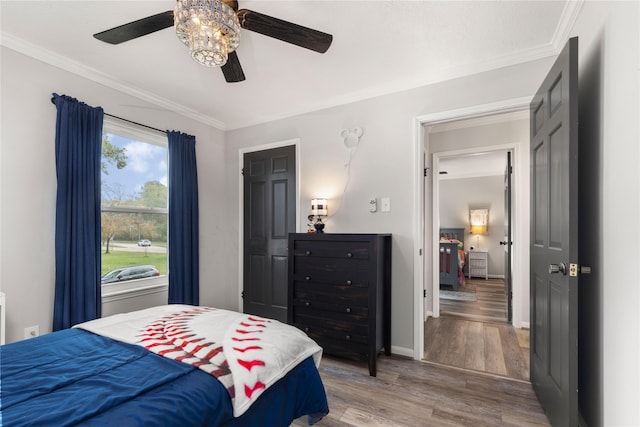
100 116 169 304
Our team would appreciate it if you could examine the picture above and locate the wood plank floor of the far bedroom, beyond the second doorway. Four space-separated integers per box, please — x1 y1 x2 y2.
440 278 507 322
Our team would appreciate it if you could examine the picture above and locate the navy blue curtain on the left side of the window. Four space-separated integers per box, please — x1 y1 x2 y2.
52 94 104 331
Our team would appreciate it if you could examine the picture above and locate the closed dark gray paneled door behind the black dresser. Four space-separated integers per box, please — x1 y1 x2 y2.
242 146 296 322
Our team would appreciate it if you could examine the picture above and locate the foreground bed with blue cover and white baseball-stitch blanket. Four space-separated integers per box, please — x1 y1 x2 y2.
0 305 329 427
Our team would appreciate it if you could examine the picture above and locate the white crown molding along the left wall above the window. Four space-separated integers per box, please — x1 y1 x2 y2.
0 32 226 131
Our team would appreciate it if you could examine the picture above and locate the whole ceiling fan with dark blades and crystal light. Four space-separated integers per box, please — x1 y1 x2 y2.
93 0 333 83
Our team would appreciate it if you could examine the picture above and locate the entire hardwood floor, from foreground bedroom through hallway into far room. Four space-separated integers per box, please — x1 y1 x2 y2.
293 280 550 427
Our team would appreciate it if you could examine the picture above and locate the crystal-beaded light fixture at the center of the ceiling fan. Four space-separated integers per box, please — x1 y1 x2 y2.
173 0 240 67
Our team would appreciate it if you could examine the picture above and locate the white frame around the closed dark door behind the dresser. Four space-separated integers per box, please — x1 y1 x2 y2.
238 138 302 312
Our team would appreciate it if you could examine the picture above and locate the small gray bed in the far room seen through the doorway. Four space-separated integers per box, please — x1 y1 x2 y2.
438 228 466 291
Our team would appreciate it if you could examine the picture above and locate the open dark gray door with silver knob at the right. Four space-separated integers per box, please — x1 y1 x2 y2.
530 38 578 426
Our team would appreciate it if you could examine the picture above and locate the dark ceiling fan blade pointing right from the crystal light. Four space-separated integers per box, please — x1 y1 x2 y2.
237 9 333 53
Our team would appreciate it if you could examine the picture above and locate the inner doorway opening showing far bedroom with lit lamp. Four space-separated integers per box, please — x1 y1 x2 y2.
430 150 511 322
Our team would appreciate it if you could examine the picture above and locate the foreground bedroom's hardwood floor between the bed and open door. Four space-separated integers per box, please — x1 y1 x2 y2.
293 355 549 427
